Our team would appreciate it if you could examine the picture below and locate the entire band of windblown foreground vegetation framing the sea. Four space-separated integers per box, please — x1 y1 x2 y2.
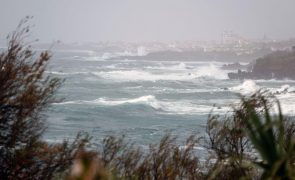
0 19 295 180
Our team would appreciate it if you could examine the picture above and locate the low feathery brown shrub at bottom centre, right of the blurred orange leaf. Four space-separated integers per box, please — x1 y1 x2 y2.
101 135 203 179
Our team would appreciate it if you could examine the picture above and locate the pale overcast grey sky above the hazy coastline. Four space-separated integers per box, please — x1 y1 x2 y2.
0 0 295 42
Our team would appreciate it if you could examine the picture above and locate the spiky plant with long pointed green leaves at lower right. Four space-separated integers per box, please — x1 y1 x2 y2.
243 95 295 179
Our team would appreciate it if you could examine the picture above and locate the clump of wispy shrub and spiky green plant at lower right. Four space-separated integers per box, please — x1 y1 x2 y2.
204 91 295 179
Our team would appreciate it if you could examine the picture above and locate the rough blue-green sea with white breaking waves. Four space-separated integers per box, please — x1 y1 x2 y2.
44 49 295 146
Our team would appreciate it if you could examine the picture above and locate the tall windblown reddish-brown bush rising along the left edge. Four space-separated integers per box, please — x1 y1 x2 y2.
0 18 88 179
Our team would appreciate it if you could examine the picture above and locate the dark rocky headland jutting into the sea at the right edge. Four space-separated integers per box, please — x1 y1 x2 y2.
228 51 295 79
